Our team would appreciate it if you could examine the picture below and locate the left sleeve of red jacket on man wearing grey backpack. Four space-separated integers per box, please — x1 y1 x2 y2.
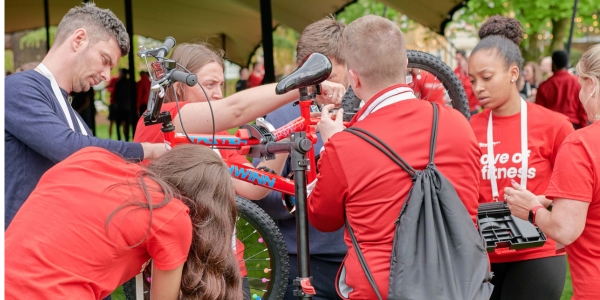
307 142 348 232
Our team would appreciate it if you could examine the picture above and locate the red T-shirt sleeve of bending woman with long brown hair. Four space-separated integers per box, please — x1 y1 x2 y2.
147 207 192 270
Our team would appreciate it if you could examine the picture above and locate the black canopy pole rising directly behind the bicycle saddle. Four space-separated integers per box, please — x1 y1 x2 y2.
260 0 275 84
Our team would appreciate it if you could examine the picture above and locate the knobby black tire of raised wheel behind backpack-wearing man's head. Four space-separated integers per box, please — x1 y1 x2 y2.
342 50 471 121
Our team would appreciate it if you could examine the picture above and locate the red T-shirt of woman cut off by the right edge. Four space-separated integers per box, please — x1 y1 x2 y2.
546 122 600 300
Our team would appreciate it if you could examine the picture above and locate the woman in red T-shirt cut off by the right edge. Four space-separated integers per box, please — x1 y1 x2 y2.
505 45 600 300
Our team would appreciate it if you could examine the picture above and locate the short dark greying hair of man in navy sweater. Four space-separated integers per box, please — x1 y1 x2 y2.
54 2 129 56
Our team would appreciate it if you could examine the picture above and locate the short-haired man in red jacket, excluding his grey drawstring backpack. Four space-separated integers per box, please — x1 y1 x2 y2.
308 16 480 299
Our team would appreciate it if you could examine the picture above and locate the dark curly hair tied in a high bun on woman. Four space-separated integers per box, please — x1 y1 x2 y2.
471 16 524 69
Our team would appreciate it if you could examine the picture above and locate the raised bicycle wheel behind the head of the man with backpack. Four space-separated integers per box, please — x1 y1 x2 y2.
342 50 471 121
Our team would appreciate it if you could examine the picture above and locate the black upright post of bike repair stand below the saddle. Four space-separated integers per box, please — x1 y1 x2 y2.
290 132 316 299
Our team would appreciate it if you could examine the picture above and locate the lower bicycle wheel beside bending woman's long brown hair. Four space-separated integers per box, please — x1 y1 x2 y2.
235 196 290 300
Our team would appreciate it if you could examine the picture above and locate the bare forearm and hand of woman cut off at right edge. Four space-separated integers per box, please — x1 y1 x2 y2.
504 183 590 245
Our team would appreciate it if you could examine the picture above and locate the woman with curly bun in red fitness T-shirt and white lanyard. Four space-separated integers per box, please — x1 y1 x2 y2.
469 16 573 300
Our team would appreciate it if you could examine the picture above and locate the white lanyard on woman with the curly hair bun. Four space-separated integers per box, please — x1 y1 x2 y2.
487 99 528 202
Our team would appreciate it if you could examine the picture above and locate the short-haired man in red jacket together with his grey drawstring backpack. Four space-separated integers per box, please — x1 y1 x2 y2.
307 15 491 300
